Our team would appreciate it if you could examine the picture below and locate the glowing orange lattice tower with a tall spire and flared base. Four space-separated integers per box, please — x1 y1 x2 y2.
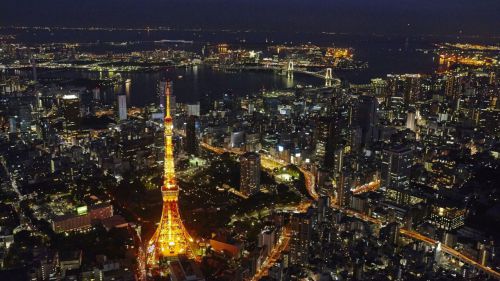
147 82 192 268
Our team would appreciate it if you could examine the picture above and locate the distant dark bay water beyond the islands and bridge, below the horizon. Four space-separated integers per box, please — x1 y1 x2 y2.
0 28 446 86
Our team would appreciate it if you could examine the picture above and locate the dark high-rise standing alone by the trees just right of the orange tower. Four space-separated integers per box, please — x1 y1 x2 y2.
240 152 260 196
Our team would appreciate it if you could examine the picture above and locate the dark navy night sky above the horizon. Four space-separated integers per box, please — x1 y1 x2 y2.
0 0 500 36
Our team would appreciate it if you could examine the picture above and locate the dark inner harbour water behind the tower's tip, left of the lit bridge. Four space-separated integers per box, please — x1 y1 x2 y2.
32 66 324 106
